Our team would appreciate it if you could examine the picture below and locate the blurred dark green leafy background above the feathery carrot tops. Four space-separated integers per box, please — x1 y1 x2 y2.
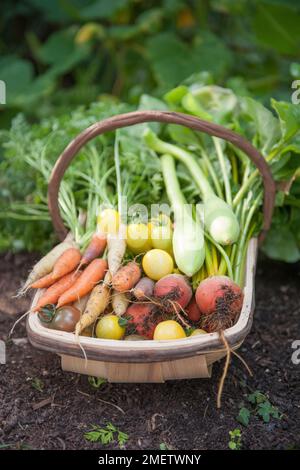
0 0 300 126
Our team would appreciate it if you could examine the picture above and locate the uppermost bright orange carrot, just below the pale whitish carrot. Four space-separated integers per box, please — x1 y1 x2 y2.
30 248 81 289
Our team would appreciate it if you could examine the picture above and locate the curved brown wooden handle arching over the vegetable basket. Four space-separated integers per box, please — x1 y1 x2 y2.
48 111 275 241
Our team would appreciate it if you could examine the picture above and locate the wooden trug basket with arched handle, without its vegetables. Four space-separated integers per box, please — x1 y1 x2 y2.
27 111 275 382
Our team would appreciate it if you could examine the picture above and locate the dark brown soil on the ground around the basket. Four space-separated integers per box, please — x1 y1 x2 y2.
0 254 300 449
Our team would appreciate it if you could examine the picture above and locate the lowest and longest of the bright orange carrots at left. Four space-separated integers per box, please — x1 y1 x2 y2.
57 259 107 307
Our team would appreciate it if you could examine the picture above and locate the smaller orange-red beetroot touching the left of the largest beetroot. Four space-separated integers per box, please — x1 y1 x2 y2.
154 274 193 312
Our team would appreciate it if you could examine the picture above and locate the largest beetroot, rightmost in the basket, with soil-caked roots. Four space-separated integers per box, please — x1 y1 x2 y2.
196 276 244 332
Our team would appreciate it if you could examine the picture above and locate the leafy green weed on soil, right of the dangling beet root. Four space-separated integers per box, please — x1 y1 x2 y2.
236 390 282 426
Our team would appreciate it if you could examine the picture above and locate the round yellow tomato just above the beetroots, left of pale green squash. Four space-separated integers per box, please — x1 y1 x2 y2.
142 248 174 281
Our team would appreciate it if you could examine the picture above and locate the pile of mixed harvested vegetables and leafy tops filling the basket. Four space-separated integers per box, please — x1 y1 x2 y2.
9 79 300 340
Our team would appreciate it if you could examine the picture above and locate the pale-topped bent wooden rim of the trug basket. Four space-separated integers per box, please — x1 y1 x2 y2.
26 238 257 363
